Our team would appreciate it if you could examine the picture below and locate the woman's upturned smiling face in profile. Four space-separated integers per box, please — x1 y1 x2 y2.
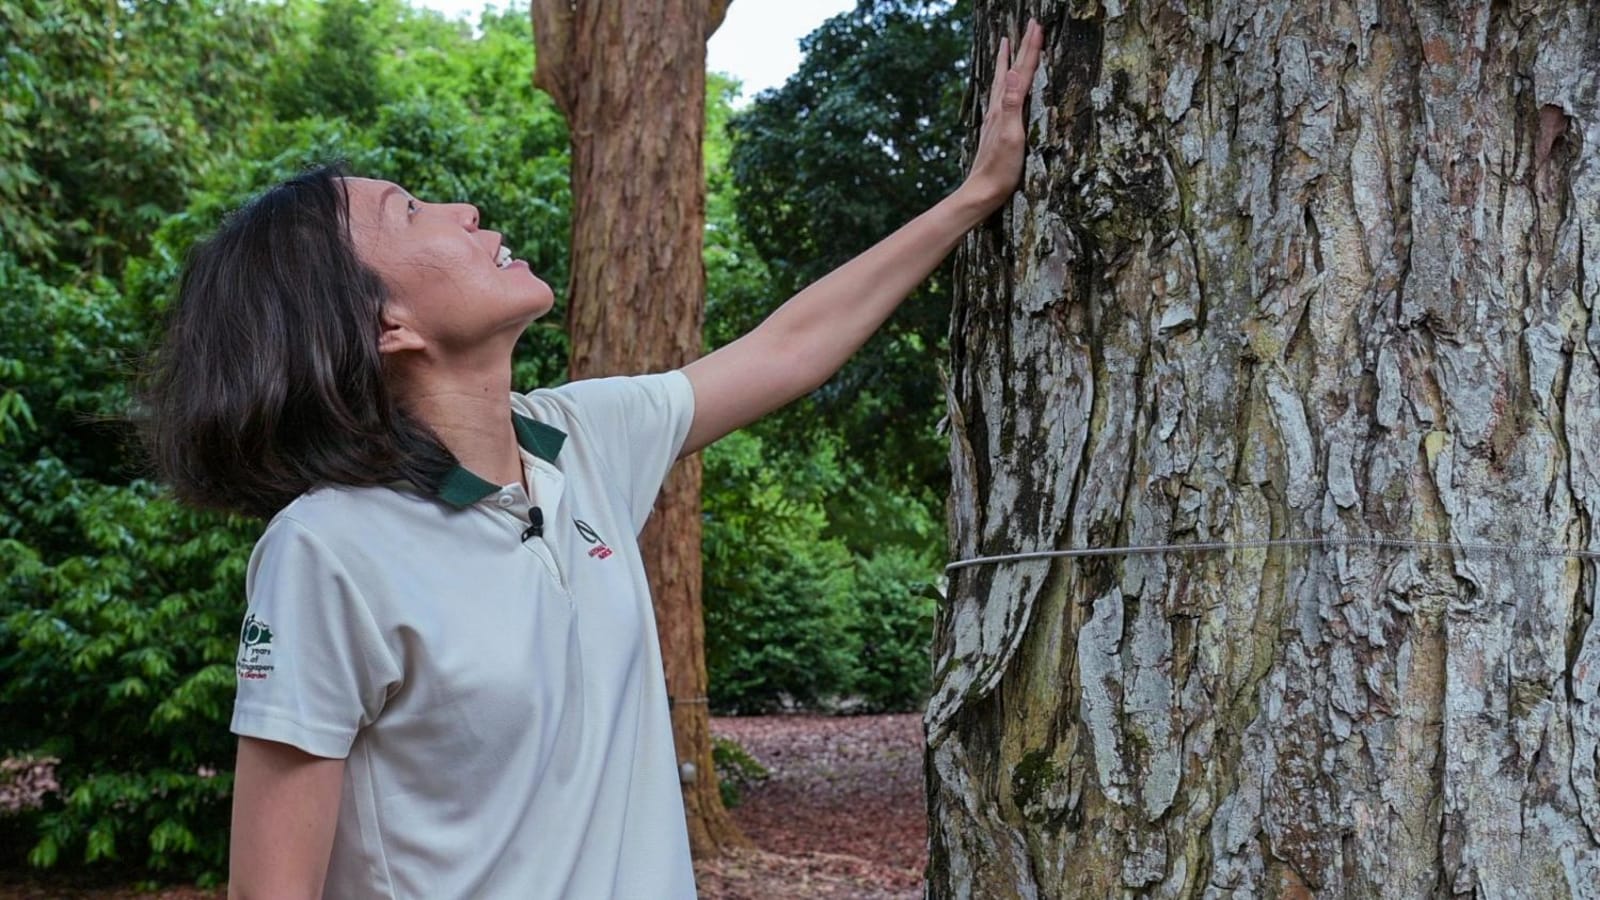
344 178 555 356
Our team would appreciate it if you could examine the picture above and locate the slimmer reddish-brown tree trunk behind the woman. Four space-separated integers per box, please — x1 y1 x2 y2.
533 0 746 857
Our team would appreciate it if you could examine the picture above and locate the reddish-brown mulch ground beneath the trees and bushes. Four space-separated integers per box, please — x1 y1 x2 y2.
0 714 926 900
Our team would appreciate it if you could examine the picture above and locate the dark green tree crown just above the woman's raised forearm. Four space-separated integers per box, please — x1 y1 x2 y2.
731 0 970 290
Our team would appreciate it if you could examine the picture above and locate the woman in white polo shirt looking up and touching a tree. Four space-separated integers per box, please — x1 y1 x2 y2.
149 24 1042 898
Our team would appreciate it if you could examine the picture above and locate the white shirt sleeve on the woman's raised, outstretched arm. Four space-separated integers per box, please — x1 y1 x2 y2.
555 372 694 535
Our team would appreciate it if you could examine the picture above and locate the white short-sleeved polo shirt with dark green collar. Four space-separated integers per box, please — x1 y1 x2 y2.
232 372 694 900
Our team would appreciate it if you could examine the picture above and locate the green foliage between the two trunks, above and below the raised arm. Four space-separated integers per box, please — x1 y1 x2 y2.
704 0 966 711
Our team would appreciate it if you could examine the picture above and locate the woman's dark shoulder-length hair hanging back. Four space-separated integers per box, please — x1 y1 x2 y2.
136 165 454 517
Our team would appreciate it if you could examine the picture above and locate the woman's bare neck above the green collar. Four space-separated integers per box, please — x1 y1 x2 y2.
397 353 523 484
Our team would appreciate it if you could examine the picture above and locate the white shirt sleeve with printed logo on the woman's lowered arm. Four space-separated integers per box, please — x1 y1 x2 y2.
232 517 400 759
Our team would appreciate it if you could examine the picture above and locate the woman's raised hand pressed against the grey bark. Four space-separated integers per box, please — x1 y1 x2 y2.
960 19 1045 215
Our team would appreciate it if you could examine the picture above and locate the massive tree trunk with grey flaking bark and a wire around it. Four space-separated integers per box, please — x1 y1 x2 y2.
928 0 1600 898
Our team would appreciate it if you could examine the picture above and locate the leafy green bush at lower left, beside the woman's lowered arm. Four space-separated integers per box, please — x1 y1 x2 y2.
0 456 258 876
